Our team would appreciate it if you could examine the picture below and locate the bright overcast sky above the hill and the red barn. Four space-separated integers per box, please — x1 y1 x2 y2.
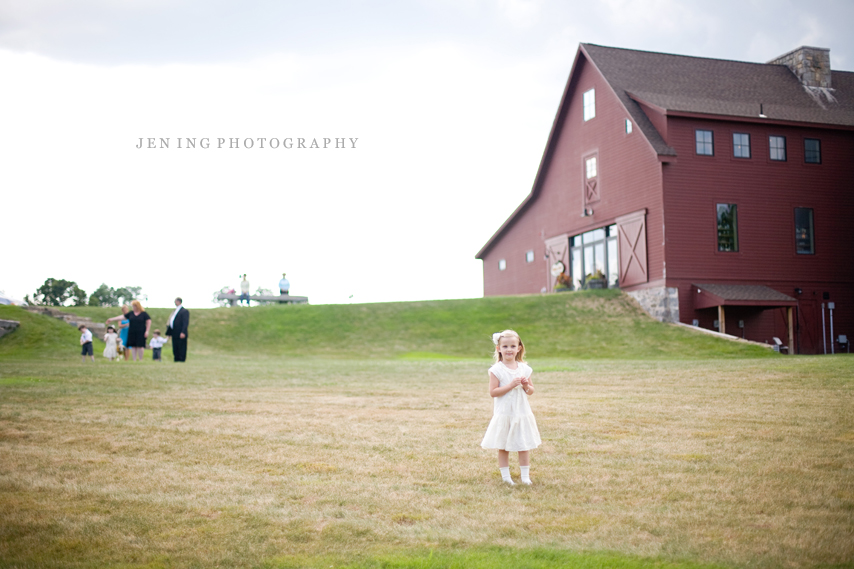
0 0 854 307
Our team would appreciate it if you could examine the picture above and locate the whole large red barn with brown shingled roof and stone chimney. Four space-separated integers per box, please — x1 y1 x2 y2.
477 44 854 354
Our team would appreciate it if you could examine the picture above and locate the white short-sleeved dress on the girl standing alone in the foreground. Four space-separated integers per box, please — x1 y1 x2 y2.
480 362 542 452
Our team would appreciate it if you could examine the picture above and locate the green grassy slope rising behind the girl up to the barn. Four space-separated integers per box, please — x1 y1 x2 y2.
48 290 774 359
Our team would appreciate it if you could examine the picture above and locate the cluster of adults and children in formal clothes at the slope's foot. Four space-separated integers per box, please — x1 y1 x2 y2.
79 297 190 362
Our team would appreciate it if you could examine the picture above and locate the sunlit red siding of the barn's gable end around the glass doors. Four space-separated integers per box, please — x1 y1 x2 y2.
483 56 664 296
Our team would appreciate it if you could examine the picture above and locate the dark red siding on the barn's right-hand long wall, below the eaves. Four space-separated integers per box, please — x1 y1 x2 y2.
664 117 854 353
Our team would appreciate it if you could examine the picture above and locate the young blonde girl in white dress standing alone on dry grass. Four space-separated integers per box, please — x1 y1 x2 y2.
480 330 542 486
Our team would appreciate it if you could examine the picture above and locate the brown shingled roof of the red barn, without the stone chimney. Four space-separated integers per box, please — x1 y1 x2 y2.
475 43 854 259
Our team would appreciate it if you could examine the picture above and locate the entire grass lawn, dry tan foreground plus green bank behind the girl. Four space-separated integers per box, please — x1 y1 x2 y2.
0 295 854 568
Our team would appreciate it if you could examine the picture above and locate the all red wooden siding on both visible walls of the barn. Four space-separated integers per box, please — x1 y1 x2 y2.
482 46 854 353
